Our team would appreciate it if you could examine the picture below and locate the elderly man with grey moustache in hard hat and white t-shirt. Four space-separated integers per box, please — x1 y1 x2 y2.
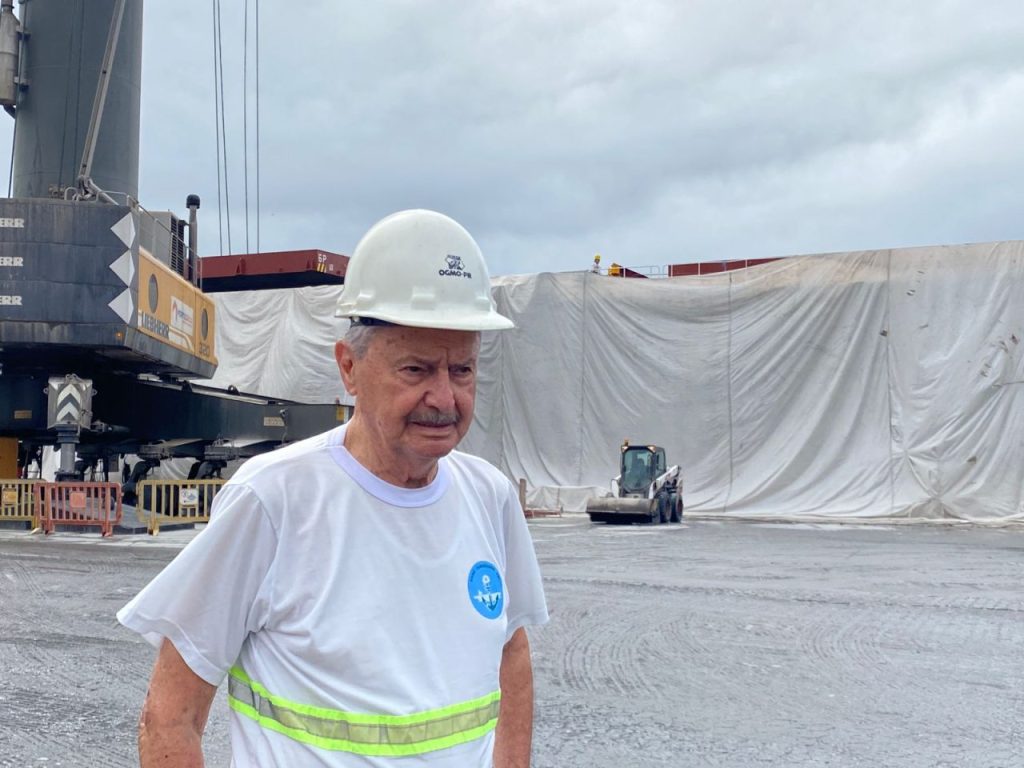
118 211 547 768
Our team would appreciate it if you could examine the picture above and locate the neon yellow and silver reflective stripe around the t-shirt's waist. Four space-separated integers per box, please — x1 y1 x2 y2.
227 667 501 757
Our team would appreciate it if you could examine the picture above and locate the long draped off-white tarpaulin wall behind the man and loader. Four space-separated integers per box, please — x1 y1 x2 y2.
203 242 1024 521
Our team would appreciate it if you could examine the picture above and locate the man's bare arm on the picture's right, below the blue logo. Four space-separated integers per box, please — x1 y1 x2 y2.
495 627 534 768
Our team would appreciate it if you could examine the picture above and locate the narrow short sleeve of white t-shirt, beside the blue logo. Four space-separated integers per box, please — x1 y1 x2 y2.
502 484 548 639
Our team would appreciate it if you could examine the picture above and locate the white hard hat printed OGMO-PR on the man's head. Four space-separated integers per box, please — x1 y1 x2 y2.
335 210 514 331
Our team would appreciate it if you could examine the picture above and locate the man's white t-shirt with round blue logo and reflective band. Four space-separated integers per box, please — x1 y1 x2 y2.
118 427 548 768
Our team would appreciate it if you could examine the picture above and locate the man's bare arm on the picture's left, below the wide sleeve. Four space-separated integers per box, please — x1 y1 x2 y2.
138 640 217 768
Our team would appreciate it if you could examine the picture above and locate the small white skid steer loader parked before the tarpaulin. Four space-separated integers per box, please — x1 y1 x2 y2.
587 440 683 523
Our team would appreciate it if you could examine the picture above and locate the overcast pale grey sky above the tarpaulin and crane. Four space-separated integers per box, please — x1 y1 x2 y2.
0 0 1024 274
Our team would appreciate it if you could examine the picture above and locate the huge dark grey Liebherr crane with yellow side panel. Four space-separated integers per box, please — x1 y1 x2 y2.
0 0 346 489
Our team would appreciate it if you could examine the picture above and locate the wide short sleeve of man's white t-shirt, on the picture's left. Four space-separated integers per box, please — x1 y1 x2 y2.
118 484 278 685
